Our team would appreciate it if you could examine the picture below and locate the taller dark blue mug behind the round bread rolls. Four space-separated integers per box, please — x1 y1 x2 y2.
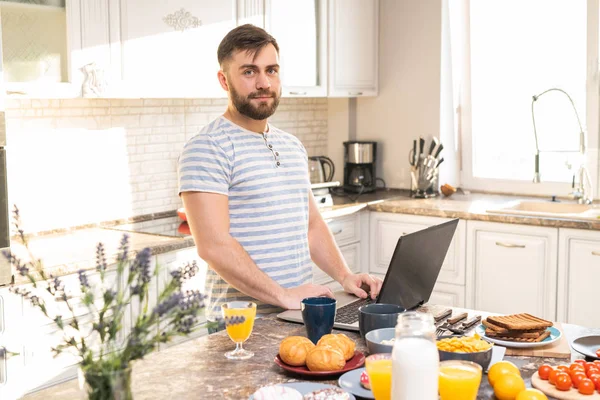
301 297 337 344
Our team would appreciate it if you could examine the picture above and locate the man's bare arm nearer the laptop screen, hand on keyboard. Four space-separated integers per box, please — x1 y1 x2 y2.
308 192 382 299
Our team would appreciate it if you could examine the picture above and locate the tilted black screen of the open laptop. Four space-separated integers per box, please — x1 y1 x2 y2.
377 219 459 310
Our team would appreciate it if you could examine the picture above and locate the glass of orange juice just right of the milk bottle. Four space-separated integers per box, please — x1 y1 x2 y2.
439 360 481 400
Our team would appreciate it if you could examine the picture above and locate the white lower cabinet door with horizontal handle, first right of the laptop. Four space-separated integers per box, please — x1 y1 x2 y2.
467 221 558 320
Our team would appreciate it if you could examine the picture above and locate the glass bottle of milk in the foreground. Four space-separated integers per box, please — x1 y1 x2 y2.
392 312 440 400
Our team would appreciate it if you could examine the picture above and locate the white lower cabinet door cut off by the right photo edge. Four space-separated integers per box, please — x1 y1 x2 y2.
557 228 600 328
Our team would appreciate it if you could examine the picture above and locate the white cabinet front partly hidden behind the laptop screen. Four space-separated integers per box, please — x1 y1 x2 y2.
370 212 465 285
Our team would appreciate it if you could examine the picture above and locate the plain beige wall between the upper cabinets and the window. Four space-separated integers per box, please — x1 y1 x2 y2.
354 0 442 188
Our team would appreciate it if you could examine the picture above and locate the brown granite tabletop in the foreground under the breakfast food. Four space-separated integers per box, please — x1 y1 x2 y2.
24 305 600 400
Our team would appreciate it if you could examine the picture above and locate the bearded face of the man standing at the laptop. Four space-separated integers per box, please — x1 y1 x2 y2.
225 44 281 120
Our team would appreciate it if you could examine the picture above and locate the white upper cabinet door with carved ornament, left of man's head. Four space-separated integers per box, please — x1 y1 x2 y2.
115 0 236 97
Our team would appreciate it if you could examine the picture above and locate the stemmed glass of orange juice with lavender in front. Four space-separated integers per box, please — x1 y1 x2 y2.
221 301 256 360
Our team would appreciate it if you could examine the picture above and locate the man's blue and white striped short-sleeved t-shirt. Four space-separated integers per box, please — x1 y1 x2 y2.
179 116 312 320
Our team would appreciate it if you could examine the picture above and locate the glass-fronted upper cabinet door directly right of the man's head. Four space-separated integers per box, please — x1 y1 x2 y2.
265 0 327 97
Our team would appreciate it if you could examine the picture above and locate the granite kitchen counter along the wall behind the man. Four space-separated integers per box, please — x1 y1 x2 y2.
5 189 600 284
